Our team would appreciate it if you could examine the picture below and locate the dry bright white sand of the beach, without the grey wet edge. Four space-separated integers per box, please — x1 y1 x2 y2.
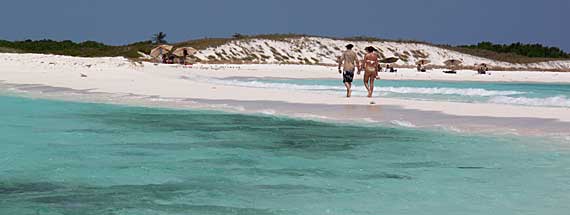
0 54 570 135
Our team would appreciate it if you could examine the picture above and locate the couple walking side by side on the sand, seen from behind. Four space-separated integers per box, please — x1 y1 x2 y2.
338 44 378 98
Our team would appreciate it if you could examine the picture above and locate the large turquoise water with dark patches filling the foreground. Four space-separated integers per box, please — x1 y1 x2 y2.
0 97 570 214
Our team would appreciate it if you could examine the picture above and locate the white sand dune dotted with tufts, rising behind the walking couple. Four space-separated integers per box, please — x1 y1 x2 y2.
196 37 570 70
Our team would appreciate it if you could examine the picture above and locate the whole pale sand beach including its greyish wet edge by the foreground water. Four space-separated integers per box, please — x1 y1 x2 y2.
0 54 570 139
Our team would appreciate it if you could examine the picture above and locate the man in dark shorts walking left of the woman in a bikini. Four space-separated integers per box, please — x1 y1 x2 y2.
338 44 360 98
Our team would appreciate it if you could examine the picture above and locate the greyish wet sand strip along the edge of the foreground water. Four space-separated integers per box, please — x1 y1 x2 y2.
0 82 570 142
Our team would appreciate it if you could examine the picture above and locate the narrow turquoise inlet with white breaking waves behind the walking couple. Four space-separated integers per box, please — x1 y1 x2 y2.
209 78 570 107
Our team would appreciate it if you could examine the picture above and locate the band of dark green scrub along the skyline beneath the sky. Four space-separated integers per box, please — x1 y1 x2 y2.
0 32 570 64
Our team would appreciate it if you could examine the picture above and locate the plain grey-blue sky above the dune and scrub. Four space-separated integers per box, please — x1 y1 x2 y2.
0 0 570 52
